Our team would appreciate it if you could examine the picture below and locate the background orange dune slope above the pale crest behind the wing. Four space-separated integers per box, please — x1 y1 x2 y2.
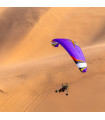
0 8 105 64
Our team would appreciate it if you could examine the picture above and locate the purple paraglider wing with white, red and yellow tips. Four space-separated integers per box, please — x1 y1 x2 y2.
51 38 87 73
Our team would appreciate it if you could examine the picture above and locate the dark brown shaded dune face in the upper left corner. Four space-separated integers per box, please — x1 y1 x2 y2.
0 8 48 62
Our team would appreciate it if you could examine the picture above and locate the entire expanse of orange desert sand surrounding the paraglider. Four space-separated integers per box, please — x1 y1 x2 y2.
0 8 105 112
